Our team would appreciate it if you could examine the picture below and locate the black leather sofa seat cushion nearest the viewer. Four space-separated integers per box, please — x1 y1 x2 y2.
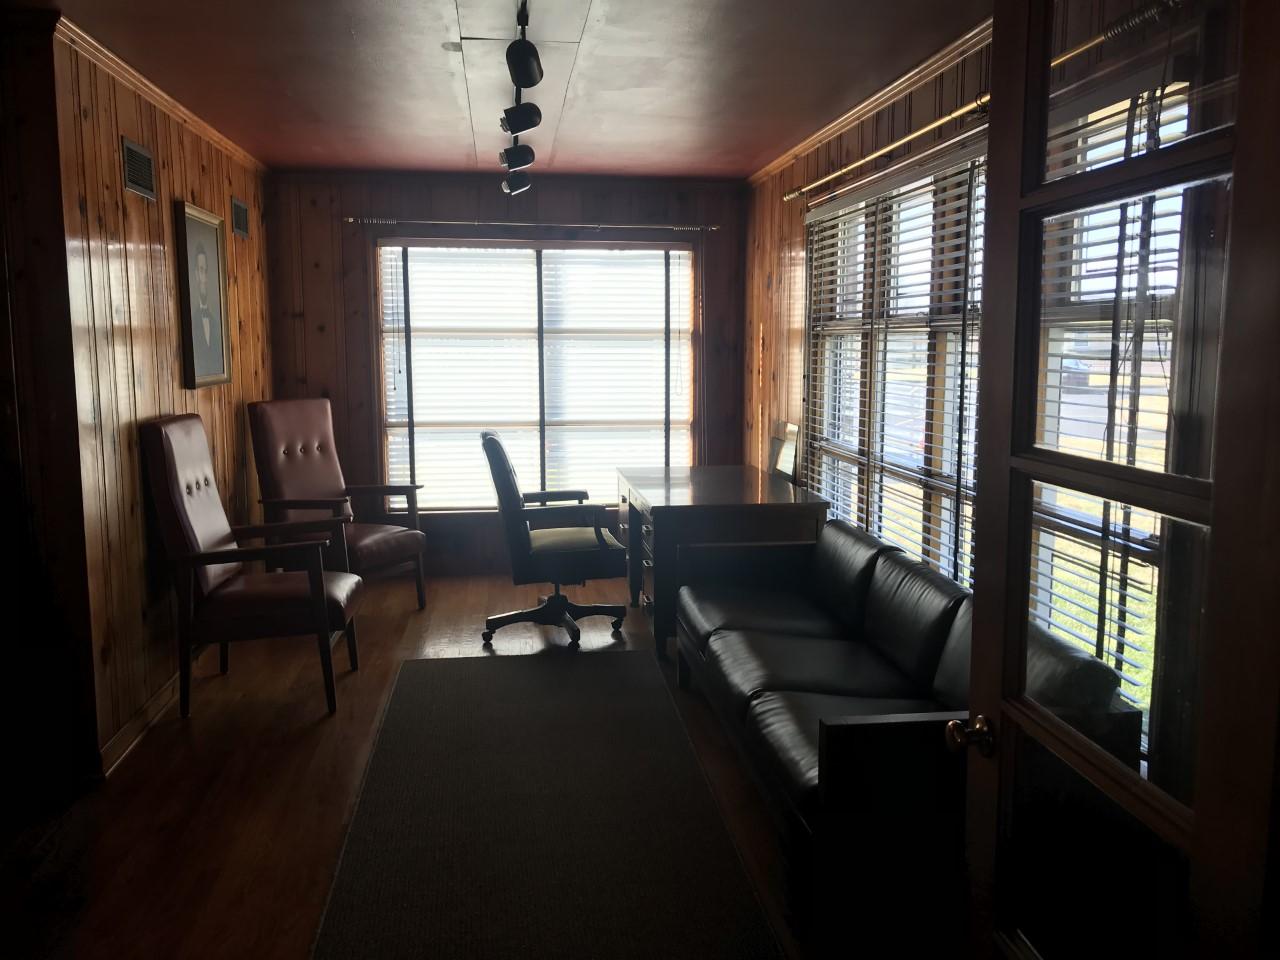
746 691 945 826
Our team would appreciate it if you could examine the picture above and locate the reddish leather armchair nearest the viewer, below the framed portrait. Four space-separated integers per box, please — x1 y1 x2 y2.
140 413 362 717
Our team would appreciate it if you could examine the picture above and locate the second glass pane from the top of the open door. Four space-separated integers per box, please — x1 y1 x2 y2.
1036 179 1230 477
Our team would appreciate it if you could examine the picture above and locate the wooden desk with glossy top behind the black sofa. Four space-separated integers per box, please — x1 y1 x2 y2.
618 466 828 658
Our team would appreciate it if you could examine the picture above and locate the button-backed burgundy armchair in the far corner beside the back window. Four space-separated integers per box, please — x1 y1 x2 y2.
248 398 426 609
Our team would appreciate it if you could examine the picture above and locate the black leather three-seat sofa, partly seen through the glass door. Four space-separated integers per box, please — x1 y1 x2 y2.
676 521 1140 952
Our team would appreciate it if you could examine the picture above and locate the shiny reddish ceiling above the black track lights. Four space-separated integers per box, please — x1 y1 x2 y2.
30 0 991 177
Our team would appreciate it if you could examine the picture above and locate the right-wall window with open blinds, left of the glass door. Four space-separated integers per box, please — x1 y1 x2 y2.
804 159 986 582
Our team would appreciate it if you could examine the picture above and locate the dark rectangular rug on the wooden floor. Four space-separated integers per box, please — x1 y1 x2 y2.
315 652 781 960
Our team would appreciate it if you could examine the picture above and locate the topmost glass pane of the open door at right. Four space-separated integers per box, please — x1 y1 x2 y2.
1044 0 1238 180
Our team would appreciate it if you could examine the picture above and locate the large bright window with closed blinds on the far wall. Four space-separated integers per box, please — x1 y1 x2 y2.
379 246 692 509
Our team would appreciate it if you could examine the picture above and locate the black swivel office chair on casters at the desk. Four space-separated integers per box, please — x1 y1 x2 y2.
480 430 627 644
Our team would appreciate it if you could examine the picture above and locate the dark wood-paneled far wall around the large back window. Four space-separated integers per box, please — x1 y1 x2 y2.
268 172 745 496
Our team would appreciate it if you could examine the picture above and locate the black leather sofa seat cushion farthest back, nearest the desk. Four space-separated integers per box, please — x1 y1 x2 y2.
676 582 844 652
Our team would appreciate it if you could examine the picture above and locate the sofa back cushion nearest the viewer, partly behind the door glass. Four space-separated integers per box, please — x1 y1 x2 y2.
933 598 1120 713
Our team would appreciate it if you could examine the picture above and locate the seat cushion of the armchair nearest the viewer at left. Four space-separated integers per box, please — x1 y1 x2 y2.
196 571 364 636
